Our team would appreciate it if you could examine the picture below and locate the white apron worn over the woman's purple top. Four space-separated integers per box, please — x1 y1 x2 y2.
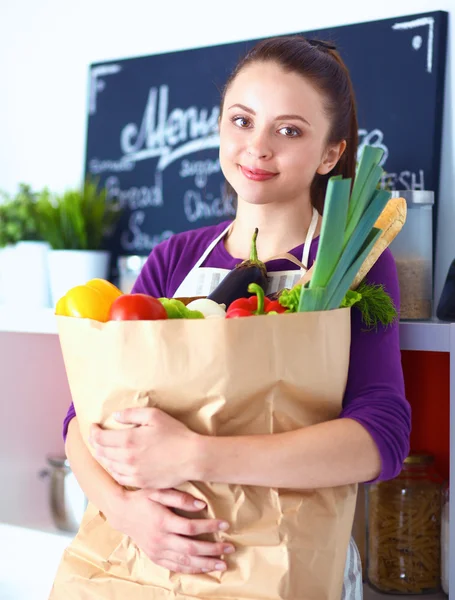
174 208 363 600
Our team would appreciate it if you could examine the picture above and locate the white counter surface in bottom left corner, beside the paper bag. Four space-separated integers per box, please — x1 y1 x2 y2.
0 523 72 600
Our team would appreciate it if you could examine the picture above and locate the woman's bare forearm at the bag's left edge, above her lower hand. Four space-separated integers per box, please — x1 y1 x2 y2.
65 418 124 516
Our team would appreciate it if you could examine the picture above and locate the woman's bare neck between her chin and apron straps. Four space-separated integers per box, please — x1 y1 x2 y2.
224 200 321 260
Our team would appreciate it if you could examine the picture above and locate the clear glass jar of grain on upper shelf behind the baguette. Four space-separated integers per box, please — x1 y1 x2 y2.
390 190 434 319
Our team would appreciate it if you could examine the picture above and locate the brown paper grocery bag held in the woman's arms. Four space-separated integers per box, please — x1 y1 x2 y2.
51 309 356 600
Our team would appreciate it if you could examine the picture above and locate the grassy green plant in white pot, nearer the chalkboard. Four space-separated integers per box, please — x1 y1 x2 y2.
38 179 120 306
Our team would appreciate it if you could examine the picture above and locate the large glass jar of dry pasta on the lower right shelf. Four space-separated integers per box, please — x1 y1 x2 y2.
367 454 442 595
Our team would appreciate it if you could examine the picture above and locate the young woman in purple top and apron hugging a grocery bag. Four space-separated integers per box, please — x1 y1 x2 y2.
65 36 410 599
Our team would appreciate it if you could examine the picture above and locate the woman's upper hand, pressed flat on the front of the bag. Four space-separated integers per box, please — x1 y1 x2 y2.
90 408 199 489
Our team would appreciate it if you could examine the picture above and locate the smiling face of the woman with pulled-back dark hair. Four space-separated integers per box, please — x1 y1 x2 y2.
220 62 340 204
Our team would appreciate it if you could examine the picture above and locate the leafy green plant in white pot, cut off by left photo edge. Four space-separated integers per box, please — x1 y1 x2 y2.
0 183 50 307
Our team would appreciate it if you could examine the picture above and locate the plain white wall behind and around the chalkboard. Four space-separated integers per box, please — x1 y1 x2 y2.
0 0 455 297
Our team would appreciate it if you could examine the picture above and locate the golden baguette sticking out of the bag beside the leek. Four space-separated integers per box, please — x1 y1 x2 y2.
351 198 407 290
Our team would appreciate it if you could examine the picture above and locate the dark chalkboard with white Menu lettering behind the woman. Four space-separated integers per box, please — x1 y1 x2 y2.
85 11 447 264
